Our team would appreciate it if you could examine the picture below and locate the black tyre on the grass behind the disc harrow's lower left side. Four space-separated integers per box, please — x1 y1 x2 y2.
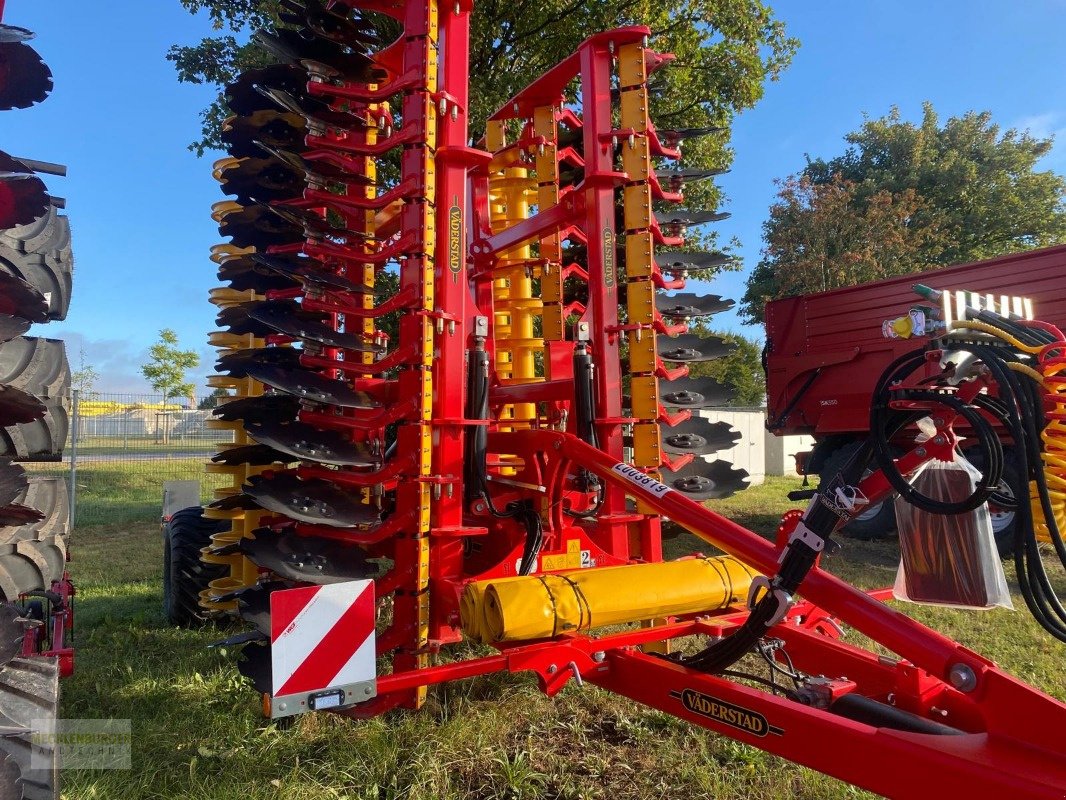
163 506 230 627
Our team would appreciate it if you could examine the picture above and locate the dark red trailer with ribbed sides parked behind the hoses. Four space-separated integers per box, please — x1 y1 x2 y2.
765 245 1066 550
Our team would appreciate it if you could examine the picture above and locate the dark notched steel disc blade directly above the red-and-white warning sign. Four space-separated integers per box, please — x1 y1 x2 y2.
241 528 379 584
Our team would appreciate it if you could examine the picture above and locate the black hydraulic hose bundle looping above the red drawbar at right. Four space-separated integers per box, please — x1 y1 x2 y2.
677 296 1066 673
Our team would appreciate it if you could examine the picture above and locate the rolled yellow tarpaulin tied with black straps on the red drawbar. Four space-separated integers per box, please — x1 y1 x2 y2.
459 556 757 642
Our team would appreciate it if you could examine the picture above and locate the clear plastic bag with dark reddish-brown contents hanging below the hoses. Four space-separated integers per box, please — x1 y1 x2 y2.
892 453 1014 609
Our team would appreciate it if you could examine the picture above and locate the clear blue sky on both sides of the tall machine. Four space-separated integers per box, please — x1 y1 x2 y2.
0 0 1066 391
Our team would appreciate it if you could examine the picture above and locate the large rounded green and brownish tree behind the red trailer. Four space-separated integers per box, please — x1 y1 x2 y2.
741 103 1066 322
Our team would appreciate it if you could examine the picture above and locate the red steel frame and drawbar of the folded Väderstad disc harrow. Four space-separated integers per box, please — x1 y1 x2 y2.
210 0 1066 798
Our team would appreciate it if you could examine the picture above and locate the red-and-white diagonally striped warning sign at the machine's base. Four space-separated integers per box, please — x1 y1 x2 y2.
270 580 376 698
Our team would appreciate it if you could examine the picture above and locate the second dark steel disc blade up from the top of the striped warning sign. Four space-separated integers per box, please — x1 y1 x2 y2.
243 473 381 528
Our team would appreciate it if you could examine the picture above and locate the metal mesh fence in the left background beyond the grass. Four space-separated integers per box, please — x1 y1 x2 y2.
26 390 232 527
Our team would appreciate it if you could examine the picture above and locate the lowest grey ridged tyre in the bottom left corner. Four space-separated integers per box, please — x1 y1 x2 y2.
0 656 60 800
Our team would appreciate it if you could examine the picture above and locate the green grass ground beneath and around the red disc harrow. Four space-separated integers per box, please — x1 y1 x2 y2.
62 477 1066 800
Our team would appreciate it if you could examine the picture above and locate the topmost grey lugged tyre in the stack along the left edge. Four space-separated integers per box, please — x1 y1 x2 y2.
0 208 74 320
